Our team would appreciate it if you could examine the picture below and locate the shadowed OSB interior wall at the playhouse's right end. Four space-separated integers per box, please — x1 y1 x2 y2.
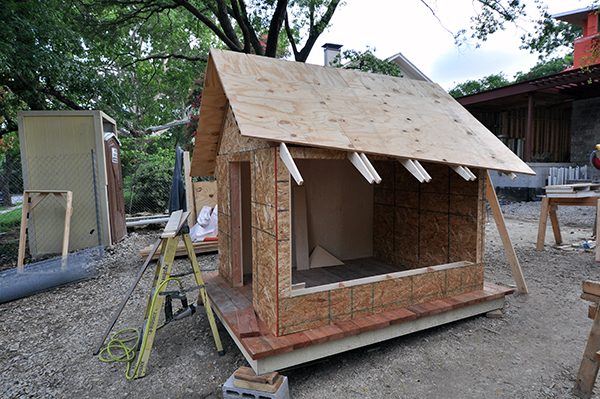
373 161 485 269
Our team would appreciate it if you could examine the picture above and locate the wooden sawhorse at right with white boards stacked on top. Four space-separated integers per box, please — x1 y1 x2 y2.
535 195 600 262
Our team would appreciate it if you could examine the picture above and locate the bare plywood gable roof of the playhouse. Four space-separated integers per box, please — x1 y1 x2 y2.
192 50 534 176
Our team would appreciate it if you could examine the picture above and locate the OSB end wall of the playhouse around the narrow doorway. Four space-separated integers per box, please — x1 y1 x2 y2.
216 105 291 334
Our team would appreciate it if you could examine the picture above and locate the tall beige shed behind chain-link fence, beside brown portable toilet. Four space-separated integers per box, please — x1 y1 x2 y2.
19 112 104 258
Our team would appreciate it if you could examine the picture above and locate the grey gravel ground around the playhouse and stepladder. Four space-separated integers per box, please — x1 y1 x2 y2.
0 203 600 398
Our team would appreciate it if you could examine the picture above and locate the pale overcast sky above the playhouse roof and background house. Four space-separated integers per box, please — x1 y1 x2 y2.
308 0 590 89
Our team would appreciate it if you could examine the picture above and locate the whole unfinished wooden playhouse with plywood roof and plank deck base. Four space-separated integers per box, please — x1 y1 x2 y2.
192 50 533 373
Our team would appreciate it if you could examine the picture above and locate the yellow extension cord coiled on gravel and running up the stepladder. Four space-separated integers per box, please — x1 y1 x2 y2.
98 278 183 381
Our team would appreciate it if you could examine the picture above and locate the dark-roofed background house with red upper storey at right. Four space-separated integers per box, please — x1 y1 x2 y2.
457 7 600 197
